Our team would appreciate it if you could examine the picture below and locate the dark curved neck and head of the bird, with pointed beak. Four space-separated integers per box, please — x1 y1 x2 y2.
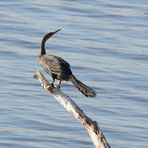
40 29 61 56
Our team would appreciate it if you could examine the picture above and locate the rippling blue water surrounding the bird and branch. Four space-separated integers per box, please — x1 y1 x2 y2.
0 0 148 148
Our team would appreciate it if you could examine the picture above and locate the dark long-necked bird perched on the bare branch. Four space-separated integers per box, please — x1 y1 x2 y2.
39 29 96 97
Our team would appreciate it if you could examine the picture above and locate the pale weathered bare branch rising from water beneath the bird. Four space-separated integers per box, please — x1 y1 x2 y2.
34 71 110 148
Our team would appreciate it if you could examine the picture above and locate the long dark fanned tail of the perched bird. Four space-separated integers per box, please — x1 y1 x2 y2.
70 75 96 97
